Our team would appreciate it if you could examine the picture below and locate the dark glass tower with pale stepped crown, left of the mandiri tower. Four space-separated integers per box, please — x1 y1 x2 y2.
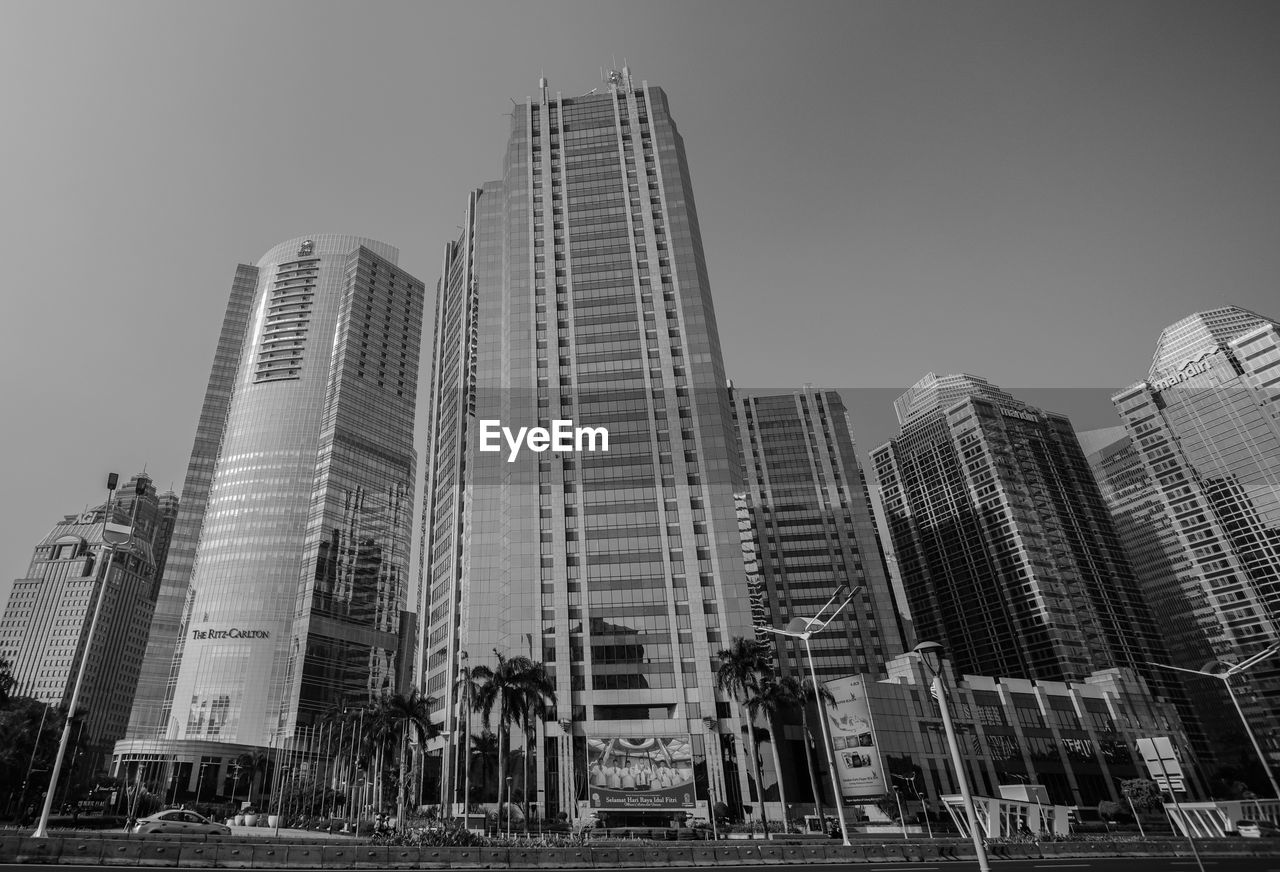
873 374 1167 691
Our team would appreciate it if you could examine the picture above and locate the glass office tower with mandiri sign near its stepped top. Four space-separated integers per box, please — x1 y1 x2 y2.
1112 306 1280 768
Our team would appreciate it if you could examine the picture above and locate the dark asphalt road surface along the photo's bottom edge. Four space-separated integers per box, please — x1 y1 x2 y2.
0 857 1280 872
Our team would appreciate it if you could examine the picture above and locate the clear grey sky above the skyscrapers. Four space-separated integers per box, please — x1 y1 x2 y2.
0 0 1280 612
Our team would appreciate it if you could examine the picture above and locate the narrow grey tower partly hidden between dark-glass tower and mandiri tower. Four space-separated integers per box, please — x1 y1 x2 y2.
1079 426 1223 764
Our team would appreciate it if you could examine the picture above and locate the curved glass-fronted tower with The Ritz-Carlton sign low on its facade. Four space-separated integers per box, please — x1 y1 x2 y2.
116 234 424 796
